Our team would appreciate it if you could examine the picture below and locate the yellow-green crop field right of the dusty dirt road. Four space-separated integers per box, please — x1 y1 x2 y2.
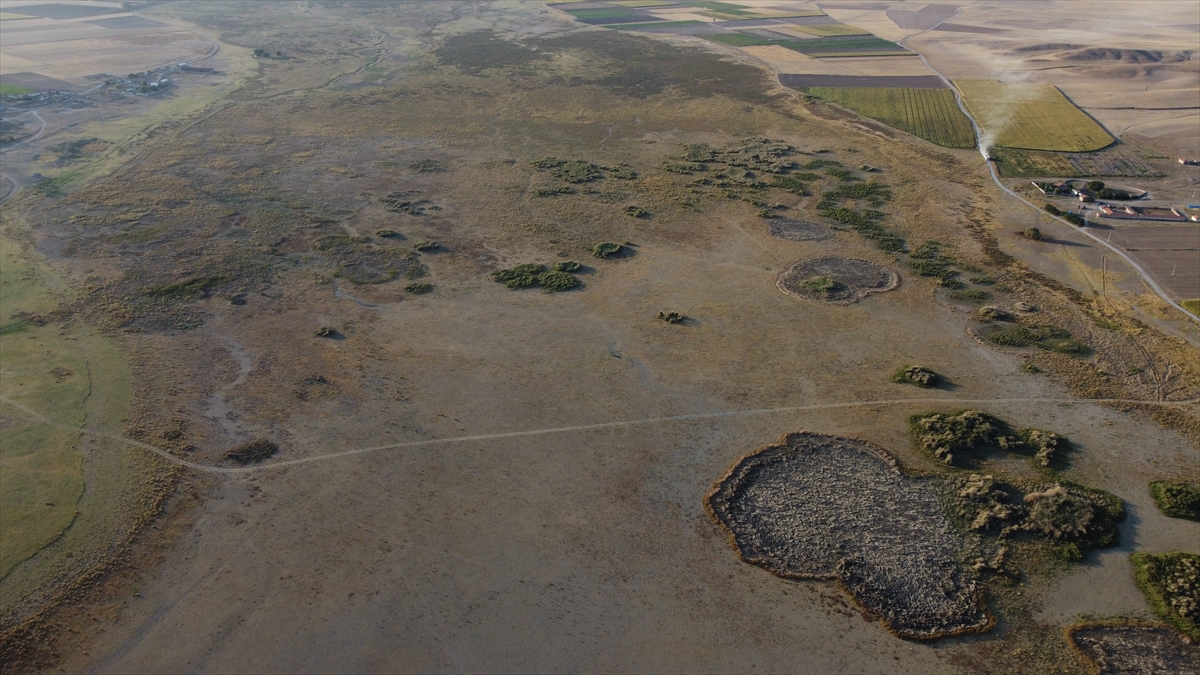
954 79 1116 153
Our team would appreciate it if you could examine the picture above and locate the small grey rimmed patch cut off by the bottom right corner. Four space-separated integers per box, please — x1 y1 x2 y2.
1067 623 1200 675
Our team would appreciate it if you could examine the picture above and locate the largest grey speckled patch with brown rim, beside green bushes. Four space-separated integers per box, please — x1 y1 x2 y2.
706 432 991 639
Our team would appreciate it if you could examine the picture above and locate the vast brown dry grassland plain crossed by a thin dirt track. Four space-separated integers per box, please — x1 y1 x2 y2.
4 2 1200 673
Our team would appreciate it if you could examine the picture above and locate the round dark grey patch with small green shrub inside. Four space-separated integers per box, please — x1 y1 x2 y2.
775 256 900 305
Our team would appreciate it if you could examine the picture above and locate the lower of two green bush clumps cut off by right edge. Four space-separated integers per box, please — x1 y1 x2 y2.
1129 551 1200 640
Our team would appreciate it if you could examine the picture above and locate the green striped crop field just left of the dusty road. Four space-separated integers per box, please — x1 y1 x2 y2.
808 86 974 148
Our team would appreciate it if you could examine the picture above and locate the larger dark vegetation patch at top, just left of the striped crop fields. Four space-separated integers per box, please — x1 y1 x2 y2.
533 31 774 103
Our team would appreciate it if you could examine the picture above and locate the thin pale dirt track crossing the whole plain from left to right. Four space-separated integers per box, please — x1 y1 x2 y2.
0 396 1200 474
